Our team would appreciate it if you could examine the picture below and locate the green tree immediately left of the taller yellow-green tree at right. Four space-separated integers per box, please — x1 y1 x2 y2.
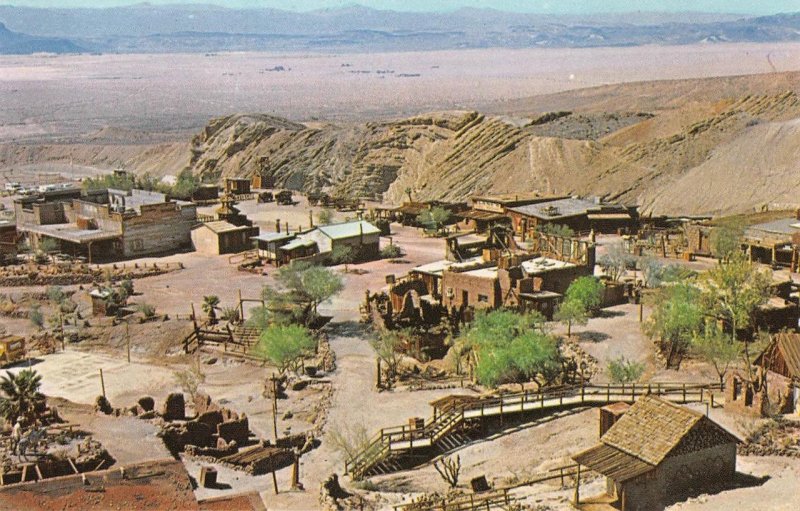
643 283 704 367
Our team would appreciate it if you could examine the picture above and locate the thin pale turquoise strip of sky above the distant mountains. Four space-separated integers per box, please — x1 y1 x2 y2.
0 0 800 14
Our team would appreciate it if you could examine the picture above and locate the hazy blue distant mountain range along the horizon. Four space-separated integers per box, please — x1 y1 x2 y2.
0 4 800 54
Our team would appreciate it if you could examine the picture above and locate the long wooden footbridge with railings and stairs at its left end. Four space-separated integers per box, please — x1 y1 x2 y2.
345 383 721 480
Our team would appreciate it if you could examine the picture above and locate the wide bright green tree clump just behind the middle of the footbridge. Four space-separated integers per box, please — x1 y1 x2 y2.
464 309 562 387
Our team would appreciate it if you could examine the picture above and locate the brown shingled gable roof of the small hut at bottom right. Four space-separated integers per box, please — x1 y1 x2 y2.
572 395 738 481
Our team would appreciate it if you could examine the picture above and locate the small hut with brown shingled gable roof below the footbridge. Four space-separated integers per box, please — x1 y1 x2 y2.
572 395 739 511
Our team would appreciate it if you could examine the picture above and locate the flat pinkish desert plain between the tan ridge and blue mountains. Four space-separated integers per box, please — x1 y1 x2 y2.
0 43 800 141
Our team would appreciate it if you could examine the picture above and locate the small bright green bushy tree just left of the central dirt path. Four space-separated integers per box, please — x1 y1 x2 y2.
252 325 316 374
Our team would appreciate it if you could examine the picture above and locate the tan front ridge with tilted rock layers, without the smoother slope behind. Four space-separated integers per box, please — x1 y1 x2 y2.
183 83 800 213
